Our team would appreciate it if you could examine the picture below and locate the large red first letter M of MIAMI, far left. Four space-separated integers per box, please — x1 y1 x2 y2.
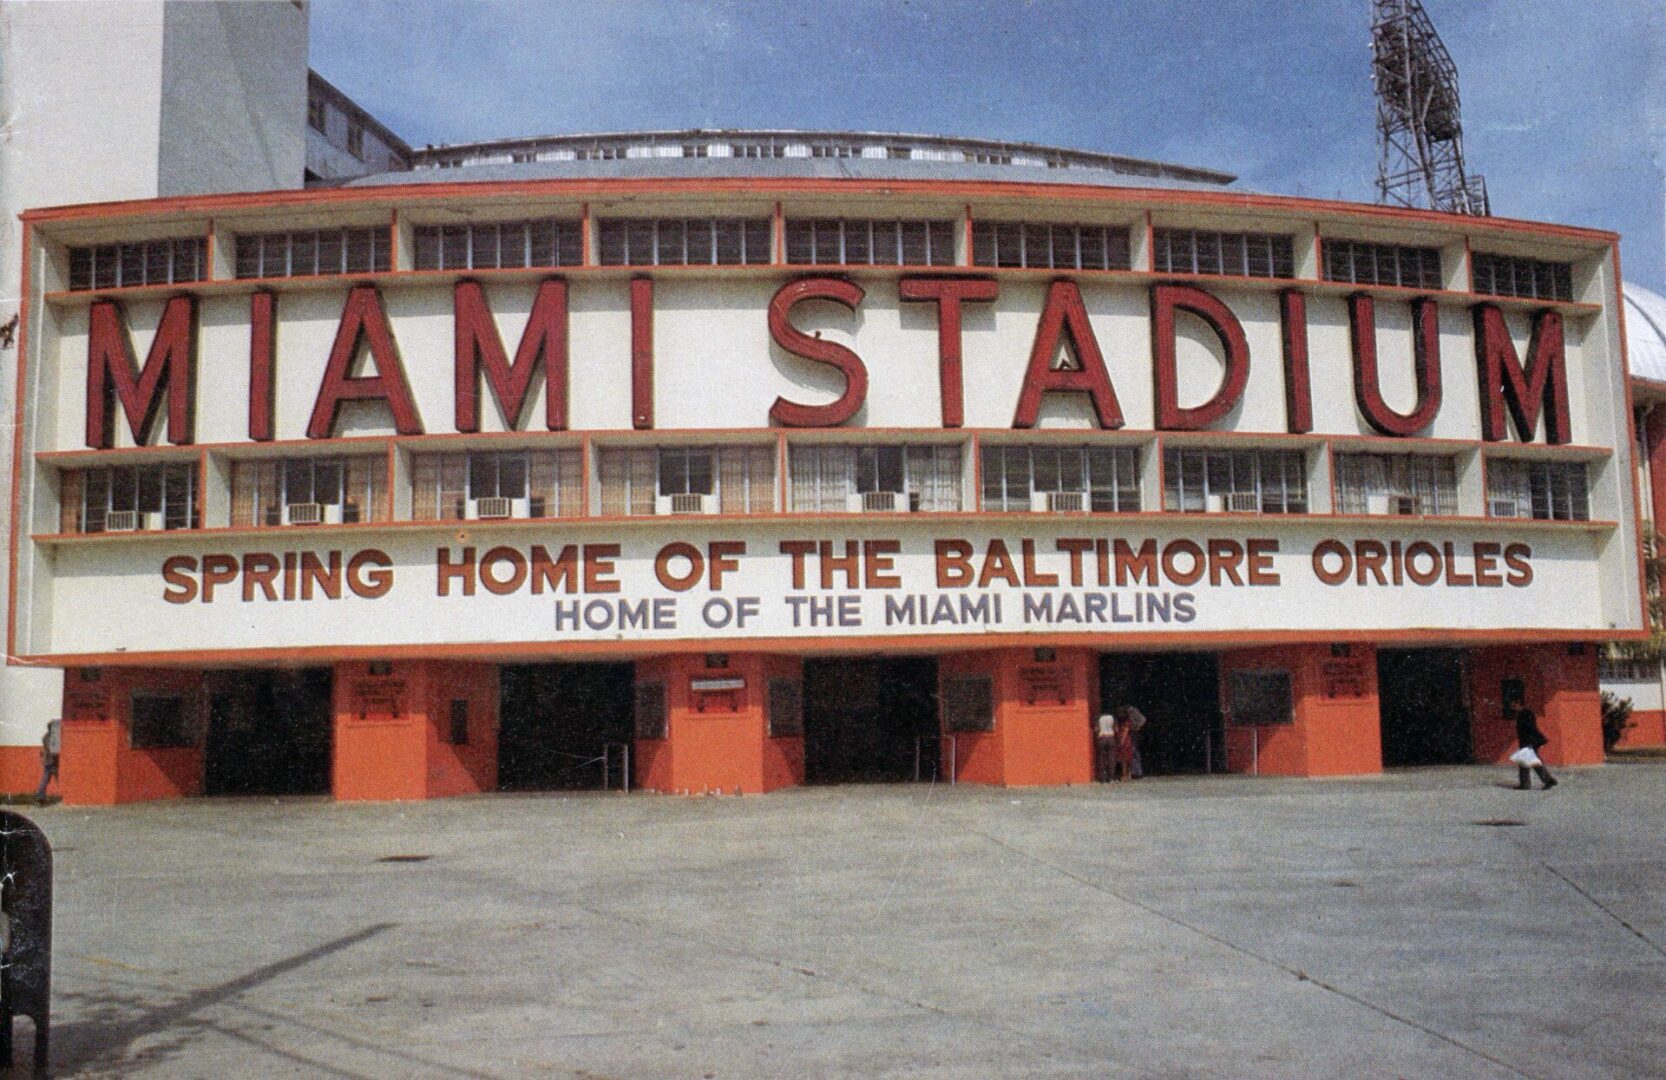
87 297 197 450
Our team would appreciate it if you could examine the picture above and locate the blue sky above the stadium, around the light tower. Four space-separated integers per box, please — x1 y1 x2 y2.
312 0 1666 288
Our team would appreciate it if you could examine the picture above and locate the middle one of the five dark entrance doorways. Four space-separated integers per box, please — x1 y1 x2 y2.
805 657 938 783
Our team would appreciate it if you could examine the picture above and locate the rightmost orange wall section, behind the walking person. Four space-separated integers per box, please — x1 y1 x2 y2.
1469 643 1603 765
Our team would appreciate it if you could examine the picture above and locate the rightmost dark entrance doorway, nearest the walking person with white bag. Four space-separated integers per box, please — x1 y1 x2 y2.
1376 648 1474 767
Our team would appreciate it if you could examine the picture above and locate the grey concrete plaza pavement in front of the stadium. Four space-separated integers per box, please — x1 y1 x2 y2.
18 760 1666 1078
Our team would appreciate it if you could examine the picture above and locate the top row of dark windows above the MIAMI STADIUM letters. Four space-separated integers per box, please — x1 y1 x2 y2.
58 218 1573 300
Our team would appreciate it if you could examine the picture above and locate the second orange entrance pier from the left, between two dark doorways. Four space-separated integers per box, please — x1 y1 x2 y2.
332 660 498 802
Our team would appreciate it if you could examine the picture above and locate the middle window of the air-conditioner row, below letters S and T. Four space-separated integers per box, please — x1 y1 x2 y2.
788 445 961 513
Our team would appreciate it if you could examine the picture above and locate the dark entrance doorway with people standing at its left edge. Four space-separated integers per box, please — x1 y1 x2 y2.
1100 653 1225 777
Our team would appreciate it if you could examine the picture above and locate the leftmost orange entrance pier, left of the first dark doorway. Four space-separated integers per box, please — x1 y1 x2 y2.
57 668 207 805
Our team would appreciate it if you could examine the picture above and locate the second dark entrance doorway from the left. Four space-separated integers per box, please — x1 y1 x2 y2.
498 663 636 792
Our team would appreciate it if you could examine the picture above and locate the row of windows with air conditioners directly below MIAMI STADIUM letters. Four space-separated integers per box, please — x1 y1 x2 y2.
48 443 1589 533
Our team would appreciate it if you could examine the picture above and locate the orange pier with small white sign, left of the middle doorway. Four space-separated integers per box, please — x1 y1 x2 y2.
631 653 805 795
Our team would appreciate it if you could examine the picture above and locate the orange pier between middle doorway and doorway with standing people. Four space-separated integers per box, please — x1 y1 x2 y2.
938 648 1098 787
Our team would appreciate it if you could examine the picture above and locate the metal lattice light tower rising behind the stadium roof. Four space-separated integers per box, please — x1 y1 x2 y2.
1371 0 1491 215
